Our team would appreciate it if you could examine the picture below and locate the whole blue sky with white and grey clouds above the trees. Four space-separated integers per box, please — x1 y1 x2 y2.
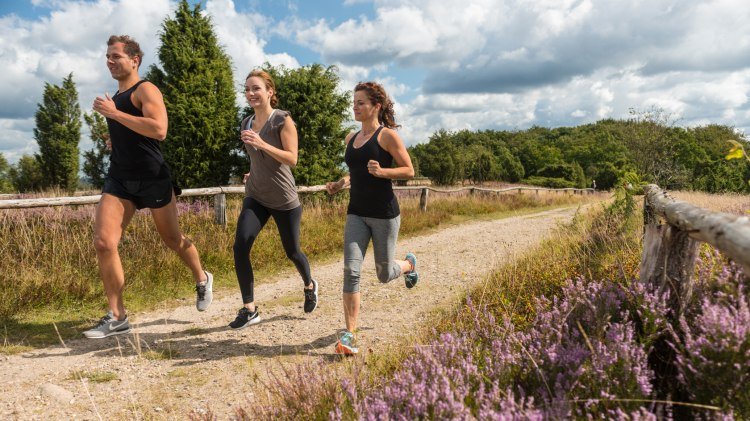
0 0 750 163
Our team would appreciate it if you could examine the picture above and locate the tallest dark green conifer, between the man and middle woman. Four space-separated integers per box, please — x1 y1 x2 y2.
146 0 240 187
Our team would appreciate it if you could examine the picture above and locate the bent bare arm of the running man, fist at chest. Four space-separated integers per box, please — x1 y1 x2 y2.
94 82 169 140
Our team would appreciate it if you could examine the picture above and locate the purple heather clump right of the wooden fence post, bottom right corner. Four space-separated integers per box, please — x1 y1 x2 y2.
674 248 750 419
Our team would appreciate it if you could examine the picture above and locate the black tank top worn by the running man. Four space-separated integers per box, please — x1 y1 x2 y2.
107 80 170 180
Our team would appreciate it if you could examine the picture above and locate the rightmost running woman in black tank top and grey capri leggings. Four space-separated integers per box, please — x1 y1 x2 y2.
326 82 419 355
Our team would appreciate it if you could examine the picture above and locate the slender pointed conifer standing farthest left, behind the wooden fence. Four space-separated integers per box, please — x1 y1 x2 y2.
34 73 81 191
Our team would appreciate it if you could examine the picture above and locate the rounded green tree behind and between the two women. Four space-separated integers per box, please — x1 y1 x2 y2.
263 64 353 186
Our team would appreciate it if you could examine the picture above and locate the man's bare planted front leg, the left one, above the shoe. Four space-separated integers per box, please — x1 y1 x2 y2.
94 193 135 320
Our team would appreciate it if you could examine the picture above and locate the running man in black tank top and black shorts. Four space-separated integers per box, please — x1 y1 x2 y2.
83 35 213 338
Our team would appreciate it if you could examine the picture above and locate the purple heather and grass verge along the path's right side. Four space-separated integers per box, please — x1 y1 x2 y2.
236 189 750 420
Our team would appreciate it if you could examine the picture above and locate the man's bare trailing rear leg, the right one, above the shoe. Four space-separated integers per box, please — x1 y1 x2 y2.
151 195 207 283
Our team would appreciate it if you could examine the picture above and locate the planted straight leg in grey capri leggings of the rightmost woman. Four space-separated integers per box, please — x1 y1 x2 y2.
343 215 371 332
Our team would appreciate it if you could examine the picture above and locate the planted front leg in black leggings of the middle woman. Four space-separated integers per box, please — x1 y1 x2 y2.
233 197 270 310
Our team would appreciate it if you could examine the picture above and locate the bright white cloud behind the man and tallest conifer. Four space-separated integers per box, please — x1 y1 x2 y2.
0 0 299 162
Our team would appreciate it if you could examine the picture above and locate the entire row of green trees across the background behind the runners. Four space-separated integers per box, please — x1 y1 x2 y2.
0 0 750 192
